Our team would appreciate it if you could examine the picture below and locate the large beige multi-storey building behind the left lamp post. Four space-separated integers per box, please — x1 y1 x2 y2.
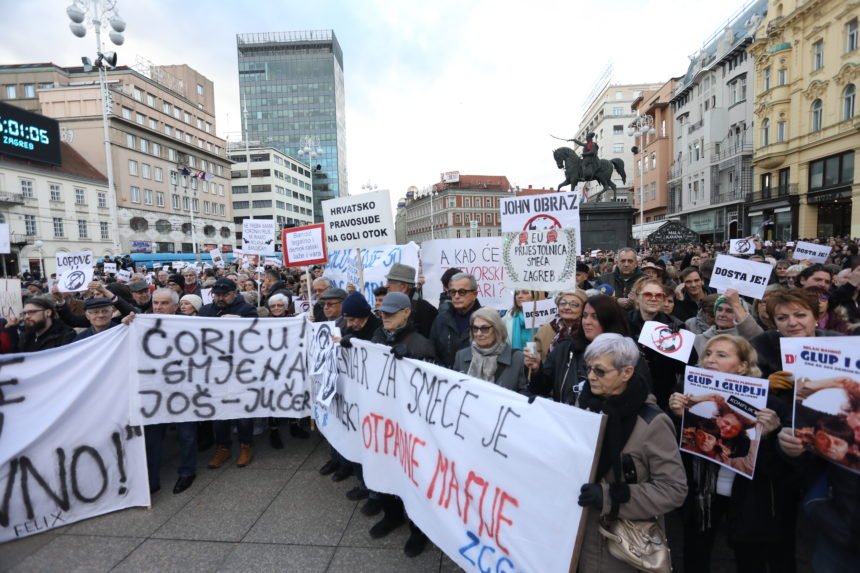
0 64 235 253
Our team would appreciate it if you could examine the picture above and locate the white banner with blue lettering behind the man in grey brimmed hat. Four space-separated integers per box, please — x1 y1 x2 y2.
323 243 419 306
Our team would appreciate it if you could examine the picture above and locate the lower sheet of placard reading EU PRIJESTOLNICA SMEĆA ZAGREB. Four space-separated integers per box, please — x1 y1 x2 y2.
502 229 578 291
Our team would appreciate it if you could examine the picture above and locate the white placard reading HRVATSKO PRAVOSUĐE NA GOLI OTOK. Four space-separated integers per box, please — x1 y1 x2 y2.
322 191 395 250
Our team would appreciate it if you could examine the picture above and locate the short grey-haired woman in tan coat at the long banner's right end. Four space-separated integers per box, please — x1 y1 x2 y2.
574 333 687 573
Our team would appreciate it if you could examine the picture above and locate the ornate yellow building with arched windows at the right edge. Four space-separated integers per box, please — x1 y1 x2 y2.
749 0 860 239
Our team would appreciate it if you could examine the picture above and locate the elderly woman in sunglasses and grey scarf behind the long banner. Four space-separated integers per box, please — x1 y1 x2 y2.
454 308 528 394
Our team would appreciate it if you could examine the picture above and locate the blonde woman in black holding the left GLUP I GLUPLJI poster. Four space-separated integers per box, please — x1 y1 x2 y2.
669 334 794 572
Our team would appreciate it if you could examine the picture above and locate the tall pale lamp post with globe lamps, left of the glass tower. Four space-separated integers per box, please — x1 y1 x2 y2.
66 0 125 255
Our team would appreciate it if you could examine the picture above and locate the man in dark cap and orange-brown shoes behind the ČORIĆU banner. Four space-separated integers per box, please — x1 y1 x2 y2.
200 278 257 469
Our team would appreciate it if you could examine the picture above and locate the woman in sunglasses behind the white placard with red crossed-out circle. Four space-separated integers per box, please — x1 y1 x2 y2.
627 278 685 410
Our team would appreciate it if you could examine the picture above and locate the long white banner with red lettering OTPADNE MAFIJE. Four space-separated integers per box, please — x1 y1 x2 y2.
314 340 602 571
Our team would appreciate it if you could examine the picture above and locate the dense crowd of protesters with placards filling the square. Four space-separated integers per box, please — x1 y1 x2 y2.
0 235 860 572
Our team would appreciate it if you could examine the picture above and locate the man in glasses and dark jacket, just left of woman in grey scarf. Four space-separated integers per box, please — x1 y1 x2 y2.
430 273 481 368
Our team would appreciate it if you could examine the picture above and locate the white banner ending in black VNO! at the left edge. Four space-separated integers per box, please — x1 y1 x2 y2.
0 327 149 542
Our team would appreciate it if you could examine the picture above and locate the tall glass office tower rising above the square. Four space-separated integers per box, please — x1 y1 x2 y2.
236 30 348 222
